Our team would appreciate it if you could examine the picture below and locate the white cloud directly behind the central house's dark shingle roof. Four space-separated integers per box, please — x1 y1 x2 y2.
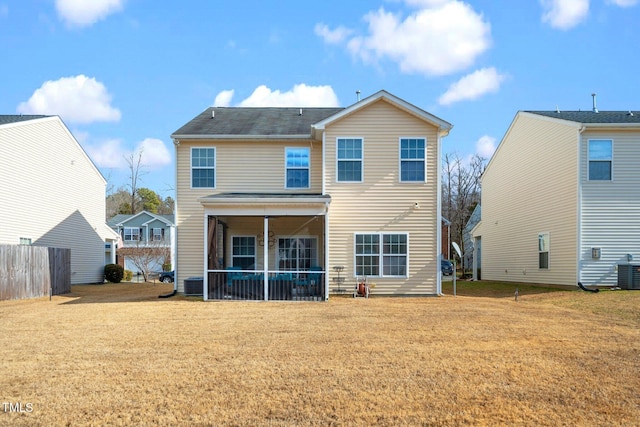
235 83 338 107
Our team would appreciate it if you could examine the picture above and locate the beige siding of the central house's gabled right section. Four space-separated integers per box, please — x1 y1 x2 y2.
325 101 440 295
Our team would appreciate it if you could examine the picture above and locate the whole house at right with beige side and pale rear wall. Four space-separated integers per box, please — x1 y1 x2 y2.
473 105 640 287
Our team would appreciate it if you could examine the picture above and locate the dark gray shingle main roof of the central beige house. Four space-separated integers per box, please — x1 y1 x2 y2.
172 107 343 137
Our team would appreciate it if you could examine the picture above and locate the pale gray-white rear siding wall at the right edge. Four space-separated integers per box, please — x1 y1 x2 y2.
580 130 640 286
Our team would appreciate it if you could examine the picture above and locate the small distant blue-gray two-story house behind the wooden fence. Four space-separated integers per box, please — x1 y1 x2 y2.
107 211 175 274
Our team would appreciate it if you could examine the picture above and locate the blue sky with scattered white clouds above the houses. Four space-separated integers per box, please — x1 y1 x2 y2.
0 0 640 201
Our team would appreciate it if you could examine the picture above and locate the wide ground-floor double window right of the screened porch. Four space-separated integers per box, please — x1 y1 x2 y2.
355 233 409 276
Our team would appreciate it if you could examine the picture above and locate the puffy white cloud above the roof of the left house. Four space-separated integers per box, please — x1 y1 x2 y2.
17 75 120 123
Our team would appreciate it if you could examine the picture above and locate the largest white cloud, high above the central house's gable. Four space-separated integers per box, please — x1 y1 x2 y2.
316 0 491 75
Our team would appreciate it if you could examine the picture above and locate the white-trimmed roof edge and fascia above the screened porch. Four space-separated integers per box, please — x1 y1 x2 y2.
198 193 331 215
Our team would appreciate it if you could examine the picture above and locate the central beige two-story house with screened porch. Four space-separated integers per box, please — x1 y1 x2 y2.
172 91 452 300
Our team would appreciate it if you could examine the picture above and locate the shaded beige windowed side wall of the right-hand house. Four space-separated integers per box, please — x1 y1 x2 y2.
475 113 578 286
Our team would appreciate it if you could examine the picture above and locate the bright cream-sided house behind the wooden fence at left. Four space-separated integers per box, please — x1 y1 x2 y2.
0 115 118 284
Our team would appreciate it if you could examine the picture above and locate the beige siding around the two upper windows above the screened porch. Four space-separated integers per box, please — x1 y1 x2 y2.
176 140 322 292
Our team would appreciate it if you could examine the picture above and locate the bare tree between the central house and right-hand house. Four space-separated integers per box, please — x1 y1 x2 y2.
442 153 486 270
